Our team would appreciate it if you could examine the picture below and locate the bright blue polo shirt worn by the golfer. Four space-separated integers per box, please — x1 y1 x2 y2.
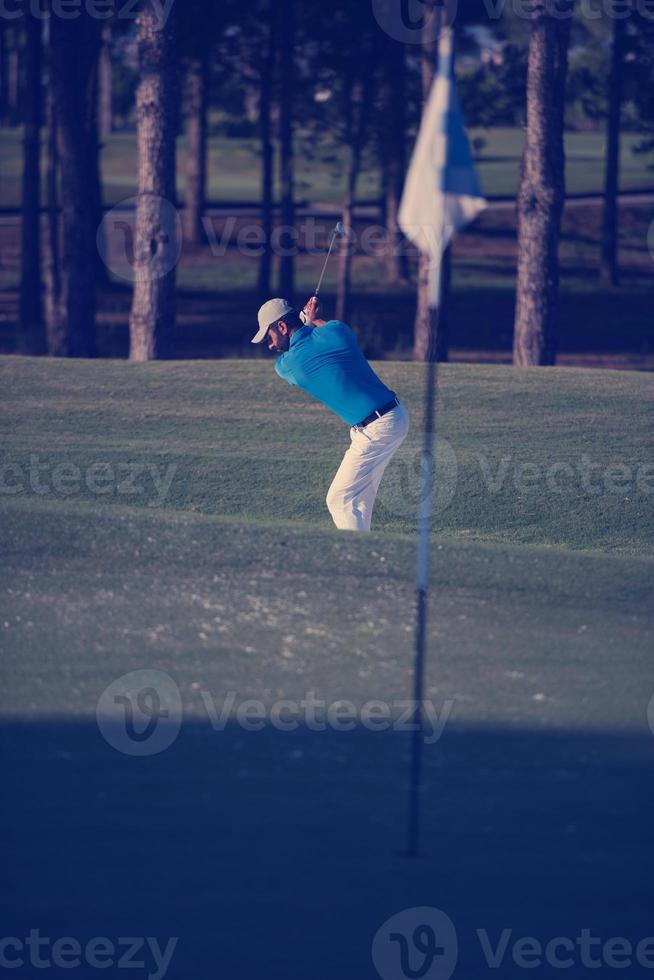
275 320 394 425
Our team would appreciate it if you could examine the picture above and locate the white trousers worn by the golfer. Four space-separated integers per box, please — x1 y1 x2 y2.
327 402 409 531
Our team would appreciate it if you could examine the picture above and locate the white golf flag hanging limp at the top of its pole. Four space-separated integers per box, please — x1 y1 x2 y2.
398 30 486 306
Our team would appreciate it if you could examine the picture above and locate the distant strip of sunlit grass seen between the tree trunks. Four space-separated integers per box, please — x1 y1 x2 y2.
0 128 654 207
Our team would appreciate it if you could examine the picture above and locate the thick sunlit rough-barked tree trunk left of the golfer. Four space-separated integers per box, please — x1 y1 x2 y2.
129 0 178 361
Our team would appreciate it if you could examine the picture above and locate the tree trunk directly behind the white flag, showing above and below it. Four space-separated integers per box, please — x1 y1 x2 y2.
413 6 450 361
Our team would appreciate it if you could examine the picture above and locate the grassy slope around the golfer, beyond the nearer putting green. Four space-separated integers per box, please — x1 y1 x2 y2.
2 359 654 554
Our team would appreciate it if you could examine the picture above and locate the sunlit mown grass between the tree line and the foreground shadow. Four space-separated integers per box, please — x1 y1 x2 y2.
0 358 654 724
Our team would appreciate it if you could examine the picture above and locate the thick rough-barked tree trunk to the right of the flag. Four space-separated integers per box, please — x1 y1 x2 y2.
513 0 574 366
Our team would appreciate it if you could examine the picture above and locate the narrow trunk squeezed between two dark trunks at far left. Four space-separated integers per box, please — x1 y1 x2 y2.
45 86 65 354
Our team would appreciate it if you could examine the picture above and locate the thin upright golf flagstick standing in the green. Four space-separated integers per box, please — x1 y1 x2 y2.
407 19 452 857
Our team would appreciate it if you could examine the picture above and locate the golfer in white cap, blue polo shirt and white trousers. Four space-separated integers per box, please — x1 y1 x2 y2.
252 296 409 531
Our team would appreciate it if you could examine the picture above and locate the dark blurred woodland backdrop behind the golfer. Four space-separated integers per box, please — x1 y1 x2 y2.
0 0 654 370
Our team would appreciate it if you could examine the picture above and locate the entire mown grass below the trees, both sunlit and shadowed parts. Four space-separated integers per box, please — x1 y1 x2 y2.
0 358 654 980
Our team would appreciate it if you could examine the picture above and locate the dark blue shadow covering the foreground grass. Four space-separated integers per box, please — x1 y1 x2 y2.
1 716 654 980
